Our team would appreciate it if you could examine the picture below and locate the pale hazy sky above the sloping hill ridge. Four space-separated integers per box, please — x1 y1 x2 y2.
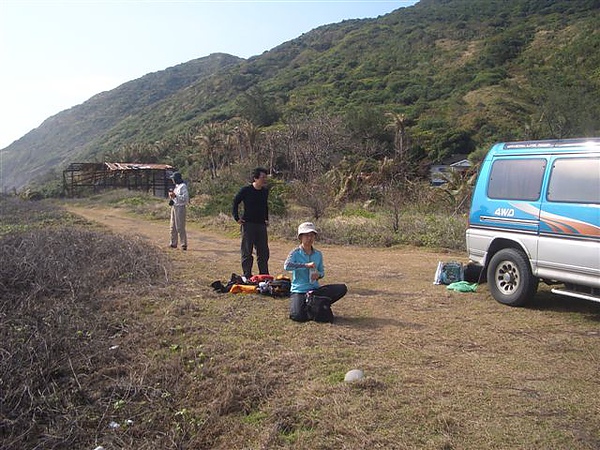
0 0 418 149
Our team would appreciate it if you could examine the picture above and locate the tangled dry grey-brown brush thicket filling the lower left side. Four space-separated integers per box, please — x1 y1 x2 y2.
0 199 165 448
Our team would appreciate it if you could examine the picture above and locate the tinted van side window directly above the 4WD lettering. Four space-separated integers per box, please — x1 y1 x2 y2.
488 158 546 200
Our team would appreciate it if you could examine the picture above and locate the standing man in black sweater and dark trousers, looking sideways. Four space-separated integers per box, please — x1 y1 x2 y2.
233 167 269 279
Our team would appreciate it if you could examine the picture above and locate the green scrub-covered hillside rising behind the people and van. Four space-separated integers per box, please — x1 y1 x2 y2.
3 0 600 199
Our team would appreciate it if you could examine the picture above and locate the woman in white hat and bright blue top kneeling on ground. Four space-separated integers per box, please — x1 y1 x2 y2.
283 222 348 322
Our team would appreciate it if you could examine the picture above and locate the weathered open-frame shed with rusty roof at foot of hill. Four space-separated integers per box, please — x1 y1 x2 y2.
63 162 175 198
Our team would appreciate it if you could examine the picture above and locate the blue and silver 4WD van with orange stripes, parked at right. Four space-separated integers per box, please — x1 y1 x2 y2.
466 138 600 306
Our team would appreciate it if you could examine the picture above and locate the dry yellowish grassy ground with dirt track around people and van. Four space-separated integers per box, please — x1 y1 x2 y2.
0 199 600 450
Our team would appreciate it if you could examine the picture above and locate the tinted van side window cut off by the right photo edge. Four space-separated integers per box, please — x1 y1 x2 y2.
548 158 600 203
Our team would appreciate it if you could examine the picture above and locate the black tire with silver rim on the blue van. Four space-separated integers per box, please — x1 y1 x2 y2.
487 248 538 306
